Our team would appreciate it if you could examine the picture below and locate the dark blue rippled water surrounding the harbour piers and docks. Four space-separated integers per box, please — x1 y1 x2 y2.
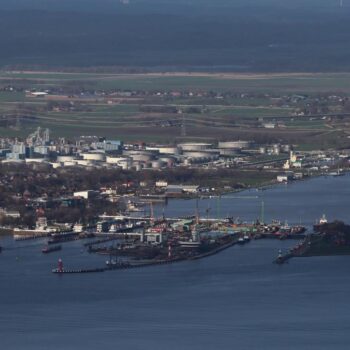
0 176 350 350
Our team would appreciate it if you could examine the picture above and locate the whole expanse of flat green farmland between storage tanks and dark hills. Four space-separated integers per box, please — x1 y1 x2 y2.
0 71 350 148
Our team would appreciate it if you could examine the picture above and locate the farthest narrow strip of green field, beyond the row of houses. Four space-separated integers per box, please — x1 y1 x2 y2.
0 72 350 93
